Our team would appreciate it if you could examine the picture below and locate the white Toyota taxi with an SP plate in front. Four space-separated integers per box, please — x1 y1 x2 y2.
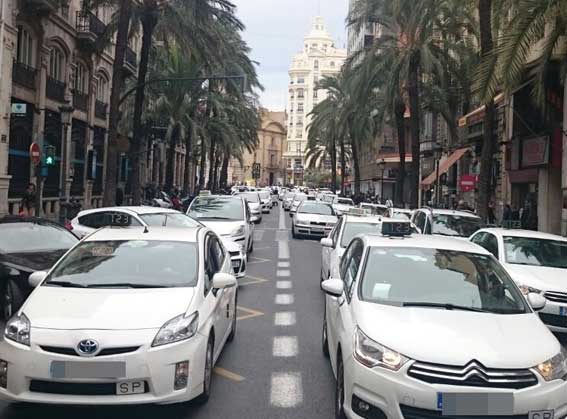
0 227 237 405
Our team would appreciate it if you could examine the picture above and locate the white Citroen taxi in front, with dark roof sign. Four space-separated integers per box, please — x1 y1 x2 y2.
322 221 567 419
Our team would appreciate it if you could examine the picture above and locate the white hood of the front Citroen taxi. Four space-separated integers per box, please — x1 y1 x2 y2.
356 301 560 368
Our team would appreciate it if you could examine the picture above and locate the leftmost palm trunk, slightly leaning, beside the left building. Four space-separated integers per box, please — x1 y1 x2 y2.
102 0 132 207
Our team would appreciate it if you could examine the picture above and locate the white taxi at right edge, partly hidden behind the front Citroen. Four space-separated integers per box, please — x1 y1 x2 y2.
470 228 567 333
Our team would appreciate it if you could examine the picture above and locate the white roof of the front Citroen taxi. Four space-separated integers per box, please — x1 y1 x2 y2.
362 234 490 255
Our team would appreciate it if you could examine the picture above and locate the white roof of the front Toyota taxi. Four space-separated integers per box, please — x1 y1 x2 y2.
83 227 203 243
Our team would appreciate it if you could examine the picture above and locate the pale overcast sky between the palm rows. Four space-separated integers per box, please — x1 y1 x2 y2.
232 0 348 111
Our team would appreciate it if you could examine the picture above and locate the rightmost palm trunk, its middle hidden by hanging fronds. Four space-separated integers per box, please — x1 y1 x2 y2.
477 0 496 220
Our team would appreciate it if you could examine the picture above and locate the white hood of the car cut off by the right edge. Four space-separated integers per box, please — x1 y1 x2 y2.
504 263 567 292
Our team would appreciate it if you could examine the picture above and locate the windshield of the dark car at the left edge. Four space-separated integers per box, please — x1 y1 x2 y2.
0 221 79 253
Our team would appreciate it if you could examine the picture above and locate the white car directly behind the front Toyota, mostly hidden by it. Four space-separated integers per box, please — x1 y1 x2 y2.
70 206 247 278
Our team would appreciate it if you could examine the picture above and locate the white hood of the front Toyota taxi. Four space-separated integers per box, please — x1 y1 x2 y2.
23 286 195 330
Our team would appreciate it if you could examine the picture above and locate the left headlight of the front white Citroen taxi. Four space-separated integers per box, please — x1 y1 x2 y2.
353 328 409 371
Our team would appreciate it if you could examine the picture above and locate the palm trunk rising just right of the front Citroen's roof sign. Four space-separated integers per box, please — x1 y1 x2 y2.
408 54 421 208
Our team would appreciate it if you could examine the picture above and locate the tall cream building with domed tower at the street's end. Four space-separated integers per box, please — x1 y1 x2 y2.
284 17 347 184
